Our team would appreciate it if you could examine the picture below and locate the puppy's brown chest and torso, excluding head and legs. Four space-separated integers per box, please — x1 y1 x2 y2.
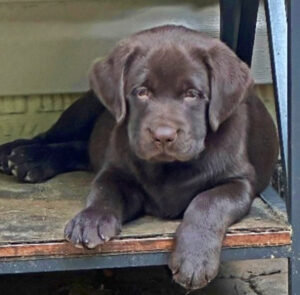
89 87 278 218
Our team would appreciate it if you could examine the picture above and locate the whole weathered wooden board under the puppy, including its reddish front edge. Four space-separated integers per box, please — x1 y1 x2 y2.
0 172 291 260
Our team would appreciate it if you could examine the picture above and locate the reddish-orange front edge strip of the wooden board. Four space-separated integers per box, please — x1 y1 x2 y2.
0 231 291 259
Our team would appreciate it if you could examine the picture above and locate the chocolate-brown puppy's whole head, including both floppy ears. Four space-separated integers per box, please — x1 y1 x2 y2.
90 26 253 162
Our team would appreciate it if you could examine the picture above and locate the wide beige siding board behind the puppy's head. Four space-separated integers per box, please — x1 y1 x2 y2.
0 0 272 95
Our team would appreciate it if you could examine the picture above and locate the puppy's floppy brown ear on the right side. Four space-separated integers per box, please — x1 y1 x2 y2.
206 41 253 131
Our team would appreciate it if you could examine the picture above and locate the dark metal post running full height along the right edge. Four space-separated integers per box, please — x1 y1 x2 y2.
288 0 300 295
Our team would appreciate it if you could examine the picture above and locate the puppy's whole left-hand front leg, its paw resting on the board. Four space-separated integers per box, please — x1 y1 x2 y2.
65 168 143 248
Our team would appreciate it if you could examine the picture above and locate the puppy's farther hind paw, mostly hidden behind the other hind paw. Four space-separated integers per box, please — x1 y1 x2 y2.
0 139 33 174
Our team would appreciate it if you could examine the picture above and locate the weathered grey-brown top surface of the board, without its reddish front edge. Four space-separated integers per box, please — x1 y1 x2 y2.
0 172 290 246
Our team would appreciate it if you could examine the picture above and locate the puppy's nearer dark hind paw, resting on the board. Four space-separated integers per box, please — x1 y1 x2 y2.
7 144 57 183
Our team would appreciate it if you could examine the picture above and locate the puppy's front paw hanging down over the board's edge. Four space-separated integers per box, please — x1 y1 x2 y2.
169 222 222 289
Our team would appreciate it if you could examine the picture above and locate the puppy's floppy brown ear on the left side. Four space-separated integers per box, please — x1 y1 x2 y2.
89 44 137 123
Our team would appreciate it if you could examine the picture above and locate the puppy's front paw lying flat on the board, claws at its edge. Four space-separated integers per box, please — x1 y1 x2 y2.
65 207 121 249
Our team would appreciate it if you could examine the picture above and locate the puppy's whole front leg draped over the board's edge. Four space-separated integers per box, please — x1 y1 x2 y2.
169 179 254 289
